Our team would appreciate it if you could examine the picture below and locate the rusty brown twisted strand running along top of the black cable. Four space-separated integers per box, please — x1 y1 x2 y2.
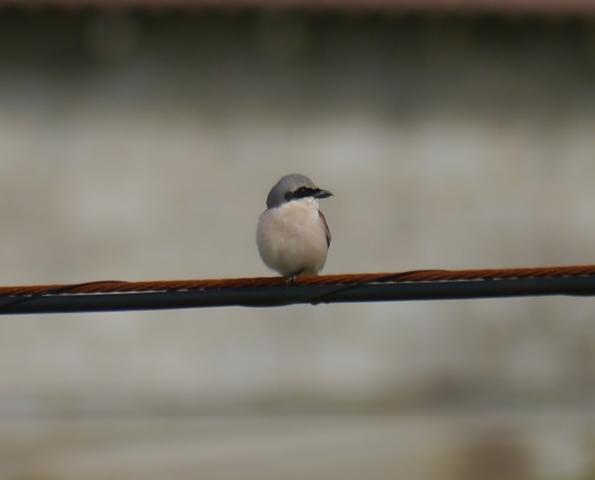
0 265 595 297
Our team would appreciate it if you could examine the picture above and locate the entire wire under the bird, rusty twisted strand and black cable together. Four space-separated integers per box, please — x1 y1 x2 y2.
0 265 595 314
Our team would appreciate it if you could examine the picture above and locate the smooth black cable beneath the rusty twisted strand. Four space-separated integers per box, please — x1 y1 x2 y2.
0 275 595 315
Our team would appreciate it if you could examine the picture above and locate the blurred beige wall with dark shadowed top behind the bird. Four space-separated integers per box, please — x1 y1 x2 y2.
0 12 595 478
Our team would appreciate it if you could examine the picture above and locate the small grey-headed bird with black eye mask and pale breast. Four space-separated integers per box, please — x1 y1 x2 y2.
256 174 332 279
